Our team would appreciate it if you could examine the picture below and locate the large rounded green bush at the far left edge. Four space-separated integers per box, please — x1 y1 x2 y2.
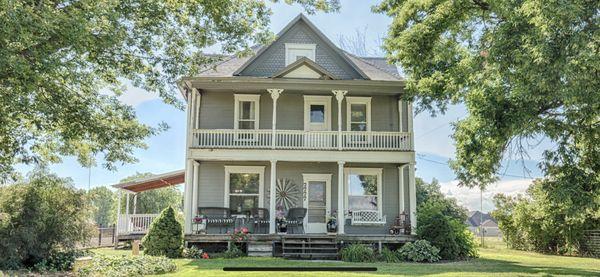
0 168 92 270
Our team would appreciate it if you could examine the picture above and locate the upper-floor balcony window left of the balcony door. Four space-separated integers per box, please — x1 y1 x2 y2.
234 94 260 129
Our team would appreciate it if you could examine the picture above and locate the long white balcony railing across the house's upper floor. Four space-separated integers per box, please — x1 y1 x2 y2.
192 129 413 151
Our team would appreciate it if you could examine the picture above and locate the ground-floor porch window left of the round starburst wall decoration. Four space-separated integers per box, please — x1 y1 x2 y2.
225 166 265 212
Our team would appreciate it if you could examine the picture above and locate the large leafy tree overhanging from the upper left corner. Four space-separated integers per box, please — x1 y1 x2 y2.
0 0 339 178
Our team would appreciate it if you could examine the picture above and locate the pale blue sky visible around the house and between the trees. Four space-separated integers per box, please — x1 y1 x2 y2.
32 1 547 210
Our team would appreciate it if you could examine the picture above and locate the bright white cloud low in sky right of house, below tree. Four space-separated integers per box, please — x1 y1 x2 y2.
440 179 533 212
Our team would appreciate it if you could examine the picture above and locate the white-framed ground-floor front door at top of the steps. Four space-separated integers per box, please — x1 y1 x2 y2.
302 174 331 233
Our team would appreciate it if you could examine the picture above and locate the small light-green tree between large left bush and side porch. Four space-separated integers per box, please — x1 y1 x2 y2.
87 187 116 227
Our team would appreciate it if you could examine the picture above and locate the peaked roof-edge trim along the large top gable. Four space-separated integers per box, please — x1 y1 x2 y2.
233 14 370 80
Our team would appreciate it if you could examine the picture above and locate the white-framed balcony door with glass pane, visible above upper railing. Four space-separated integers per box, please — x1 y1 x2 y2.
304 95 331 131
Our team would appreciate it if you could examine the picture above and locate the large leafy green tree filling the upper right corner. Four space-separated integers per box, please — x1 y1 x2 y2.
375 0 600 185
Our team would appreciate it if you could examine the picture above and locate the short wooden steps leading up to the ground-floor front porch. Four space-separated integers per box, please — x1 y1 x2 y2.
281 235 338 259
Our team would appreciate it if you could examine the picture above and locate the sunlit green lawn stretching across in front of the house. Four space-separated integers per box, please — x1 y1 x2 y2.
94 238 600 276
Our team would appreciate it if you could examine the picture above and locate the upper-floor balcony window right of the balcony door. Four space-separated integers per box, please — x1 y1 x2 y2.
346 97 371 132
